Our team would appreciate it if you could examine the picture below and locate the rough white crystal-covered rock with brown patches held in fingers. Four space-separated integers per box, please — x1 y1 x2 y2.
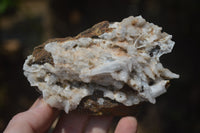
23 16 179 113
